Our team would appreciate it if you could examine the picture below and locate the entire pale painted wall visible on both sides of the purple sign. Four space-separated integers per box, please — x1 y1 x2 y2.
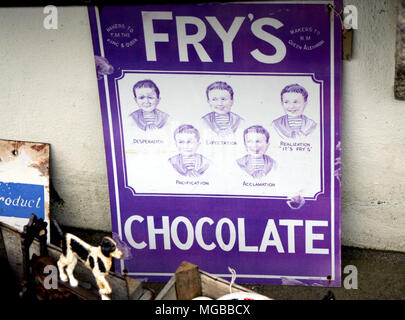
0 0 405 251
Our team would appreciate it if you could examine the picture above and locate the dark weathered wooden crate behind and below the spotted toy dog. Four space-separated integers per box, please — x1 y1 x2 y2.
0 222 154 300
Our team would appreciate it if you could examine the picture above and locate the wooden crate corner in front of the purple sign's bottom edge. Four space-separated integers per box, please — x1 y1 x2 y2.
155 261 270 300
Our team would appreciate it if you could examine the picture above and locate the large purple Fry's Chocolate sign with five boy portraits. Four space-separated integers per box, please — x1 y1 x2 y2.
89 1 341 286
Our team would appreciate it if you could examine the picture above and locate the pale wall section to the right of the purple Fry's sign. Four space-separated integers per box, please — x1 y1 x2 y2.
342 0 405 251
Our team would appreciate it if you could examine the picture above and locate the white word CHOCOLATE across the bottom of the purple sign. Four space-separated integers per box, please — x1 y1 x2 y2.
124 215 329 254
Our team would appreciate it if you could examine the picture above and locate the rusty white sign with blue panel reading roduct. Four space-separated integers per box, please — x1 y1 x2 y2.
0 140 50 235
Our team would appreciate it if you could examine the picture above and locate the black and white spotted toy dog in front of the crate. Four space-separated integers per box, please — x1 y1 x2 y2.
58 233 123 300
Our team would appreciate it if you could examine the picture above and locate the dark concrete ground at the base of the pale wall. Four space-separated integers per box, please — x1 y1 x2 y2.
0 225 405 300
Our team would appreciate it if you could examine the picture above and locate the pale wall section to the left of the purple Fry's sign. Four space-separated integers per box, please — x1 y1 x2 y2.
0 7 111 230
